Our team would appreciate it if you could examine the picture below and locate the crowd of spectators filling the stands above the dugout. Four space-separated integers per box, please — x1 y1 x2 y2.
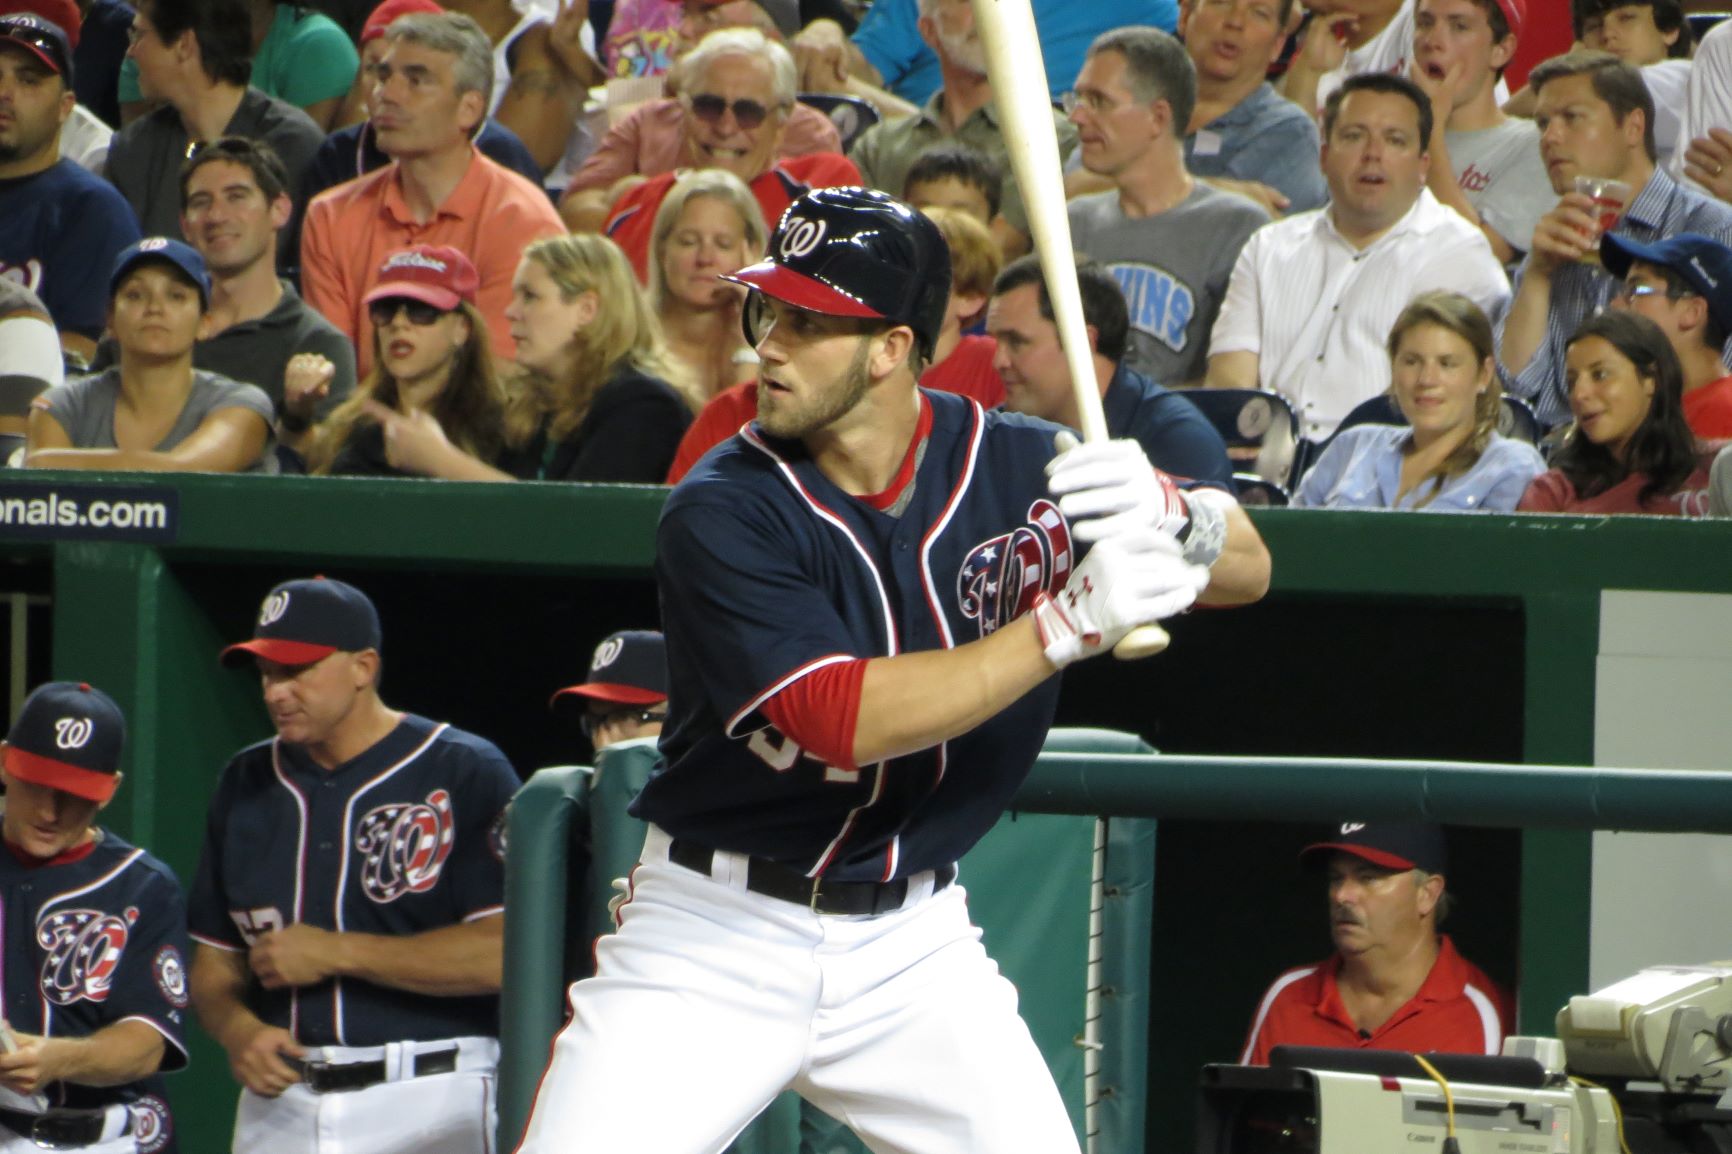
10 0 1732 515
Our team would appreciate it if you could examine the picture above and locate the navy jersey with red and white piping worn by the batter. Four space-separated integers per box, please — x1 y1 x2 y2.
632 390 1076 880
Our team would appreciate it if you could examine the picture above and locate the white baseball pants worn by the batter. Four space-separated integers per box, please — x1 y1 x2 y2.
518 828 1077 1154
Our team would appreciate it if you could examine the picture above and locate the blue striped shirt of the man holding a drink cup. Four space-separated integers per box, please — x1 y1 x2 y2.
1498 168 1732 428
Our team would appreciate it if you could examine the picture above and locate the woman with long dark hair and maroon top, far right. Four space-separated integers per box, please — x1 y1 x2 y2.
1517 312 1713 516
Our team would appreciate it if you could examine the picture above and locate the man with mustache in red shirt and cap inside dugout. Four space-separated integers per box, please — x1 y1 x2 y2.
1238 821 1510 1066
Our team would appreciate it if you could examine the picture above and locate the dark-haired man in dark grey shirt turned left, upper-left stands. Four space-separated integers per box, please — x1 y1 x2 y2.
106 0 324 269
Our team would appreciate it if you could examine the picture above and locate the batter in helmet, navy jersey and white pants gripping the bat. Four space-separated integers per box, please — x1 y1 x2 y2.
520 187 1268 1154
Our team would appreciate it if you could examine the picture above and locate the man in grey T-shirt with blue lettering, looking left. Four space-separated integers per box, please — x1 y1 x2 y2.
1065 26 1270 386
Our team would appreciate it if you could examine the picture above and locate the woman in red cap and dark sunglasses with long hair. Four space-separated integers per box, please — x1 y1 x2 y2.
304 244 506 480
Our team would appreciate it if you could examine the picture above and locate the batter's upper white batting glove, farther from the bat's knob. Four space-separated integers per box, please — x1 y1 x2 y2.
1046 431 1190 541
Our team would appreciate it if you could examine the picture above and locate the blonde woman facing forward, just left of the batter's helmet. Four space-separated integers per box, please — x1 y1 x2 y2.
650 168 769 404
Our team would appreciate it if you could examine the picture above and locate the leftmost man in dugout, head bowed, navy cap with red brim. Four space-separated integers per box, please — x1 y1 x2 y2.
0 681 187 1154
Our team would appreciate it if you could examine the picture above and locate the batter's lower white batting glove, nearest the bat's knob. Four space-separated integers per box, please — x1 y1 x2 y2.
1034 528 1209 669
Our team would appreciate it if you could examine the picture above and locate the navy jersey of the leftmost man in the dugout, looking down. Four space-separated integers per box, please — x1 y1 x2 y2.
0 830 187 1154
